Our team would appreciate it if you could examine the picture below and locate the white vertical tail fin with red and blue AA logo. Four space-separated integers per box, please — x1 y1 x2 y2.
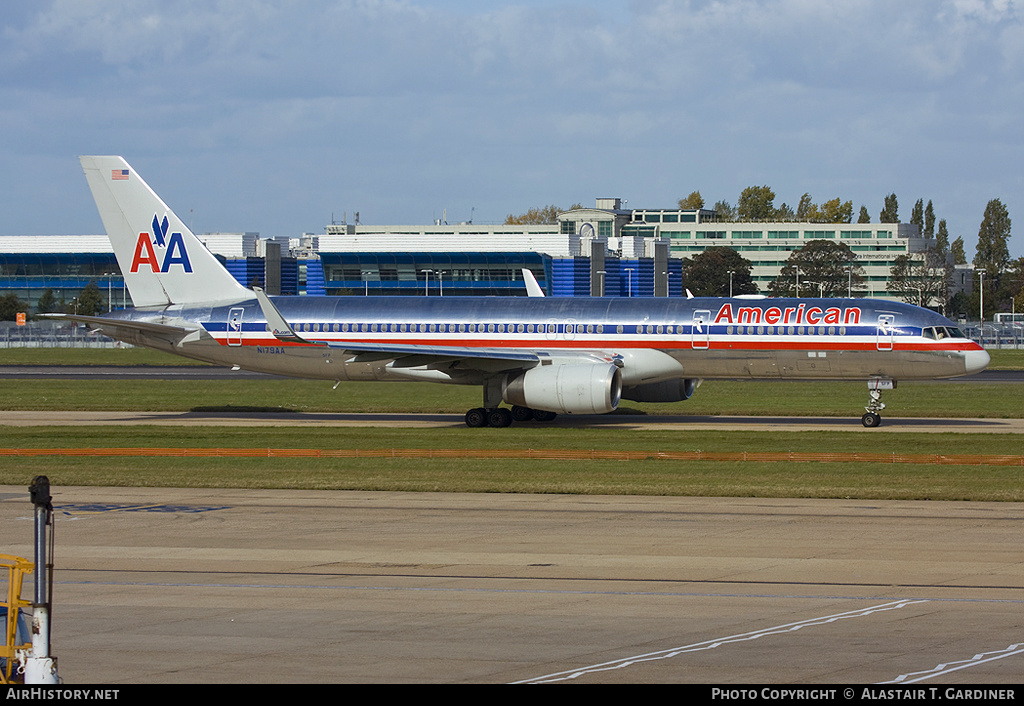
79 157 252 306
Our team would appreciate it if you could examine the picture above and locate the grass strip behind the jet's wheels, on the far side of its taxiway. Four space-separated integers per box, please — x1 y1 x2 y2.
0 378 1024 418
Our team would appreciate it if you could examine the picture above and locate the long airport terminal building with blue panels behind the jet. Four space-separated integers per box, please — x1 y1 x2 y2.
0 199 935 312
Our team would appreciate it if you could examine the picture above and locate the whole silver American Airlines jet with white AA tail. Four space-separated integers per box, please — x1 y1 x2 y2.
67 157 989 426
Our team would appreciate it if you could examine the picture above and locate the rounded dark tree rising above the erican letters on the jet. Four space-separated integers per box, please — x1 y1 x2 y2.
768 240 864 297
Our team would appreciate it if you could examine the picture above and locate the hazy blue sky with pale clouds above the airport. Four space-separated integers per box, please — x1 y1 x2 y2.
0 0 1024 256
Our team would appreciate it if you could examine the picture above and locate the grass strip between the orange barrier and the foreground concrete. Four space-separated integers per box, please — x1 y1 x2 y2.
0 450 1024 502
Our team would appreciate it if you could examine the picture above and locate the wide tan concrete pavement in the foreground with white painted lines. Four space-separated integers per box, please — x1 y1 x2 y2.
0 486 1024 686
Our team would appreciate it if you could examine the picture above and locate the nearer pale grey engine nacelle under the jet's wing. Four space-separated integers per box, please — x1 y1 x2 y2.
502 363 623 414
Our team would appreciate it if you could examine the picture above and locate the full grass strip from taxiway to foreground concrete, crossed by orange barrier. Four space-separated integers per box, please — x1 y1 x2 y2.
0 425 1024 501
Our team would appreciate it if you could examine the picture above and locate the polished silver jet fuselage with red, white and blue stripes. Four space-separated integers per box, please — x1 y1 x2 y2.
99 296 988 387
